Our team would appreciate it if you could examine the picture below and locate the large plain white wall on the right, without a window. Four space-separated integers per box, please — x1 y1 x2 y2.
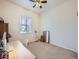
41 0 78 52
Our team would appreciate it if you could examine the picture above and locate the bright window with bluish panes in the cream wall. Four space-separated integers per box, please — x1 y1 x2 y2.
20 16 32 33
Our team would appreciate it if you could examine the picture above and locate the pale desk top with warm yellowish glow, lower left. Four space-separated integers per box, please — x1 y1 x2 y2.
9 41 35 59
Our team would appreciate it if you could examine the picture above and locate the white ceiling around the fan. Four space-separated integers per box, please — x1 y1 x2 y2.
9 0 67 13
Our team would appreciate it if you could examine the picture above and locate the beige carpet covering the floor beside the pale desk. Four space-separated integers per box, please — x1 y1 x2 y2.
27 42 77 59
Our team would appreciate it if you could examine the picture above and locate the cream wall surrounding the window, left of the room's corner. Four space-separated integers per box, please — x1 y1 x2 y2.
0 0 40 42
